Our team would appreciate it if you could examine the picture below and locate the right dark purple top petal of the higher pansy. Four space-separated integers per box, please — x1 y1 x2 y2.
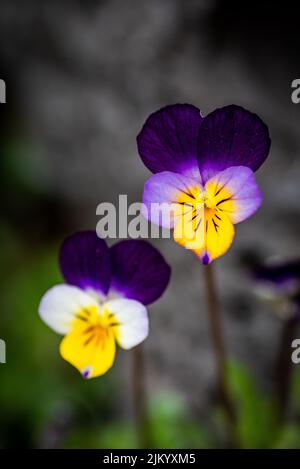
198 105 271 182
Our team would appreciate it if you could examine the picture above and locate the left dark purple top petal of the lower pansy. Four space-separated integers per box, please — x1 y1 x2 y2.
59 231 111 295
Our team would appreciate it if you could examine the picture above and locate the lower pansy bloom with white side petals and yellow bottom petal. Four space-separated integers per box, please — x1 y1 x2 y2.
39 231 170 378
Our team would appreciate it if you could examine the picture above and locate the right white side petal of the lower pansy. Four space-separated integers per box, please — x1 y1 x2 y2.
104 299 149 350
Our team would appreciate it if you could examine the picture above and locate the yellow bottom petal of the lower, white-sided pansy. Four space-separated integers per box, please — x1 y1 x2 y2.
60 319 116 378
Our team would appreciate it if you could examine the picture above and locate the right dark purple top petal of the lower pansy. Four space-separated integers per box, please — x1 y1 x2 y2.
110 240 171 305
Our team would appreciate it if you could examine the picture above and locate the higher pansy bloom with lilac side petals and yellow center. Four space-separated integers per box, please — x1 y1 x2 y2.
137 104 271 264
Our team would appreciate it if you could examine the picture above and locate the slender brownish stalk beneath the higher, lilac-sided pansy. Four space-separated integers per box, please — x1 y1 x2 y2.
204 264 235 423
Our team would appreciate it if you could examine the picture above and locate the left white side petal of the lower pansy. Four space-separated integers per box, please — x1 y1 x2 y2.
39 285 98 335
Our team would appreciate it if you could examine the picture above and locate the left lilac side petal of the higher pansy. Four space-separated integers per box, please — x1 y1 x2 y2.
143 171 201 228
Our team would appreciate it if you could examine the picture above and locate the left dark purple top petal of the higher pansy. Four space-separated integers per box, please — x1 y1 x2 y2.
137 104 203 176
